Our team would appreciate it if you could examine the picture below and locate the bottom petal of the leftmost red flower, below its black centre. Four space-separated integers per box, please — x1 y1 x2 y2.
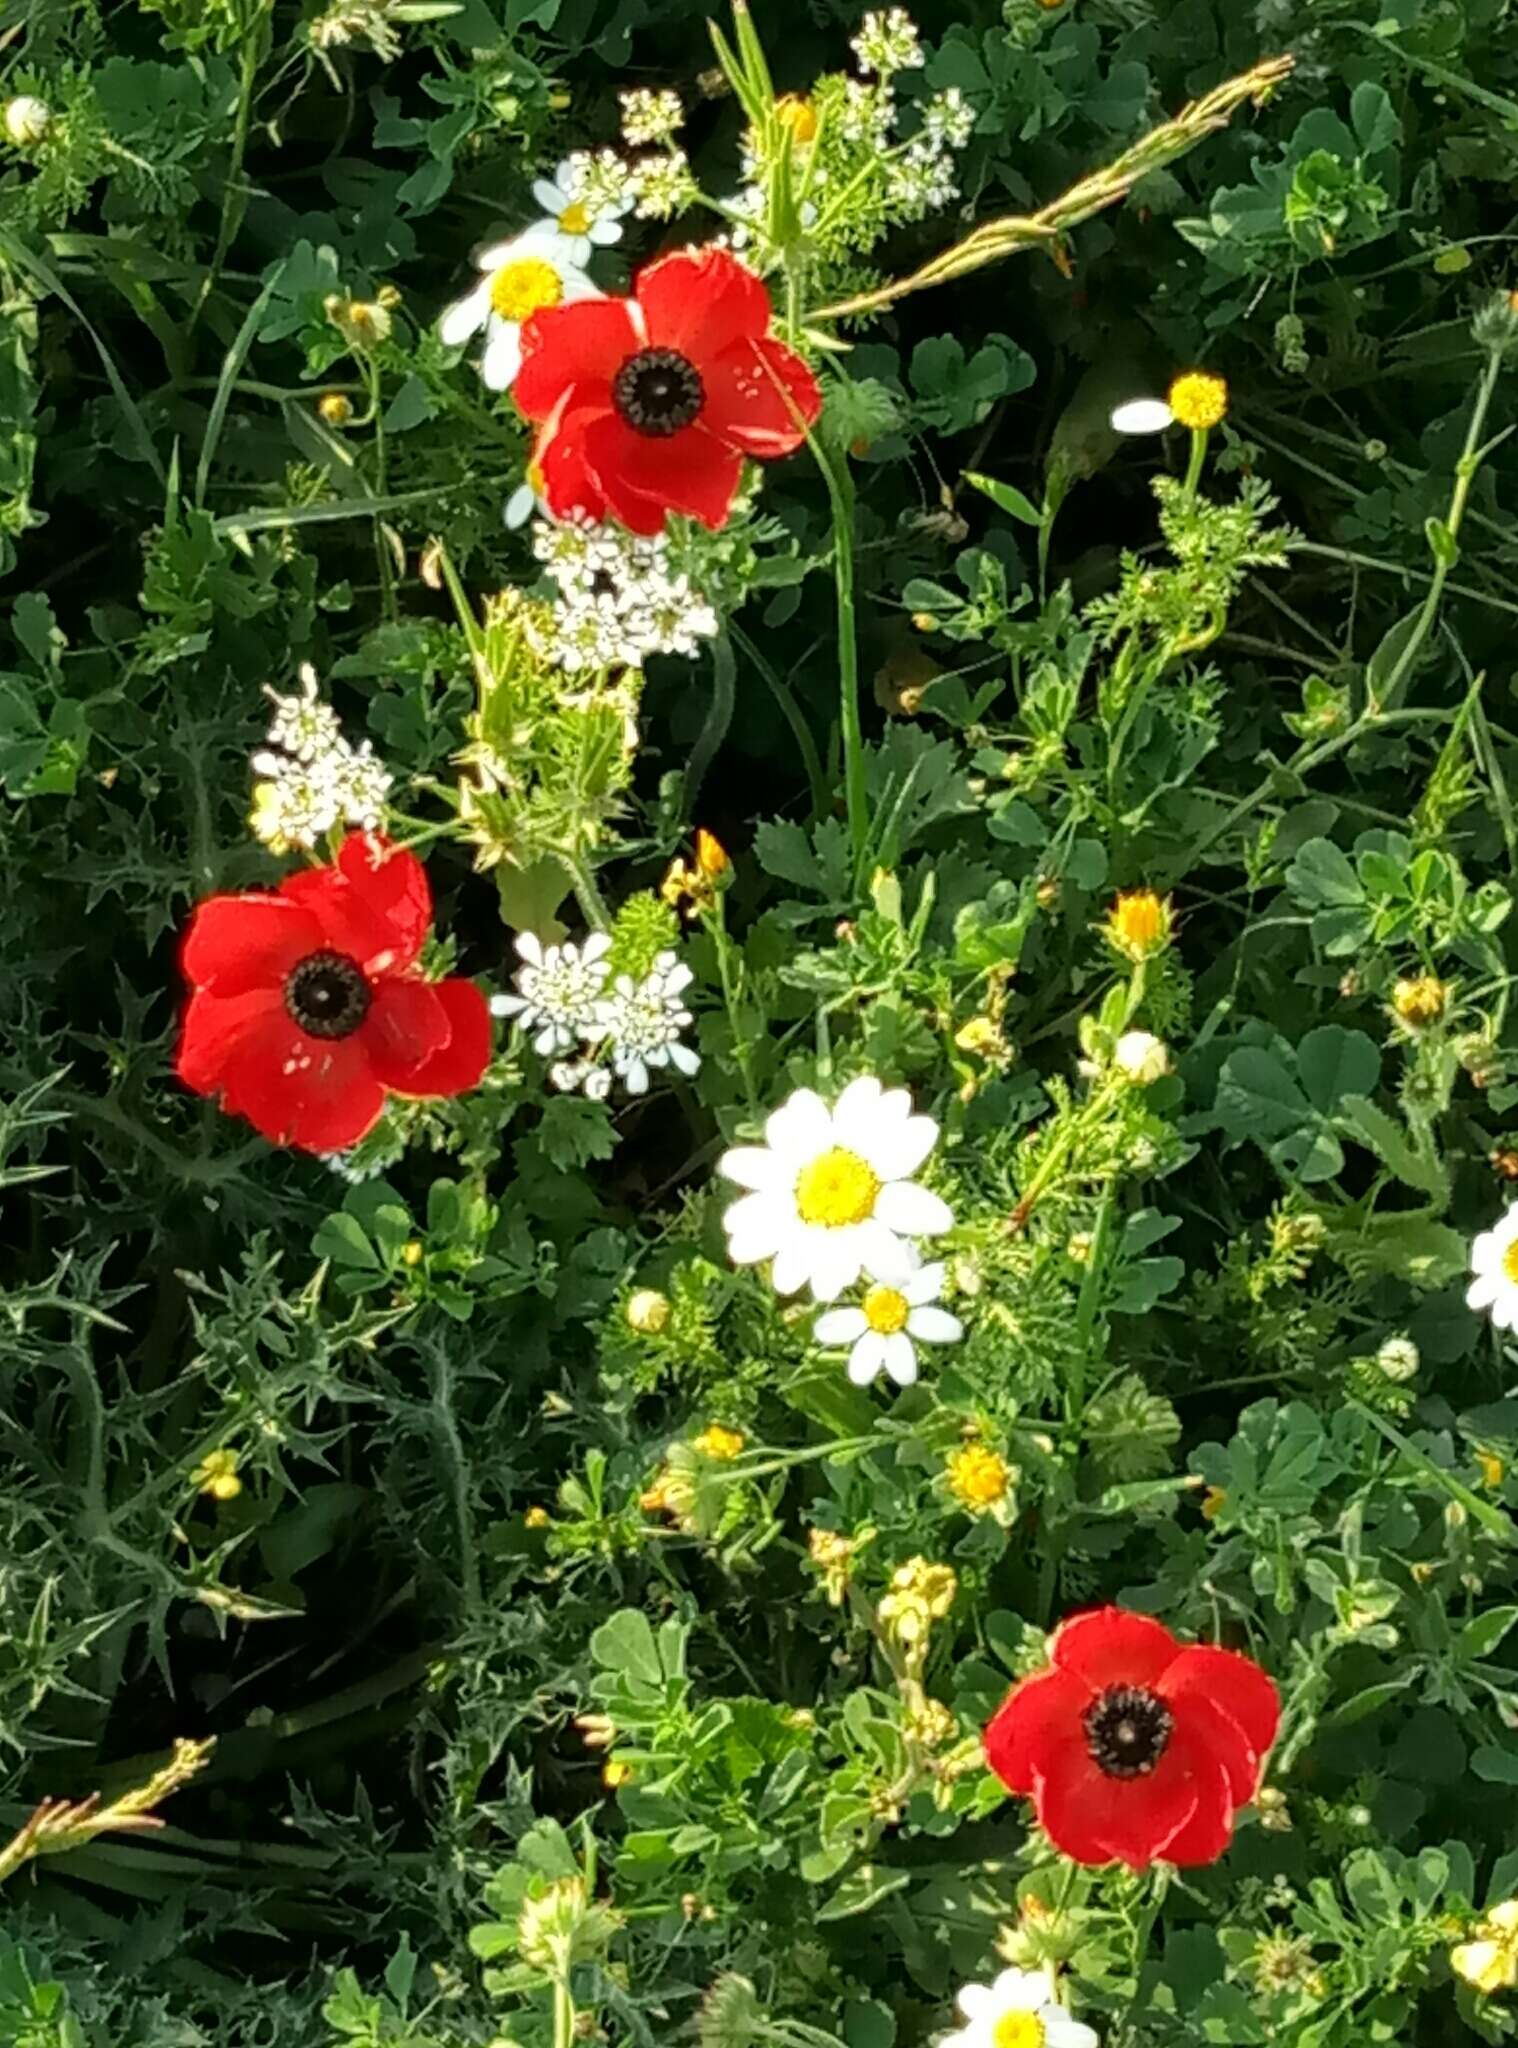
221 1008 385 1151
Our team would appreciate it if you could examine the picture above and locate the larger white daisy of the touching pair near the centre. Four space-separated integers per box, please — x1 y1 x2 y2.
717 1073 955 1300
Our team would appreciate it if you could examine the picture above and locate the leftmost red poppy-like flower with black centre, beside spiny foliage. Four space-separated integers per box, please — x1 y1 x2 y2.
174 831 490 1151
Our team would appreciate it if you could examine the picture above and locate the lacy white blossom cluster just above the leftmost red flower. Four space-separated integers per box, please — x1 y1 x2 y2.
248 662 393 854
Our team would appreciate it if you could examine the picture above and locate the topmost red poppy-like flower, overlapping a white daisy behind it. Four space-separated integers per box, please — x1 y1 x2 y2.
512 248 821 535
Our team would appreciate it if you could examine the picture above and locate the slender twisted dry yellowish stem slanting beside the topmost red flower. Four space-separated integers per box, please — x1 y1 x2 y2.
807 55 1295 319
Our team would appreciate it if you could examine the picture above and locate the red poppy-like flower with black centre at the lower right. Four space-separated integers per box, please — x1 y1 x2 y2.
985 1608 1280 1870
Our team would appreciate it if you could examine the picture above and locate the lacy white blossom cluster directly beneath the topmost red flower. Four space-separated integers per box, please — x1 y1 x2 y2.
533 520 717 676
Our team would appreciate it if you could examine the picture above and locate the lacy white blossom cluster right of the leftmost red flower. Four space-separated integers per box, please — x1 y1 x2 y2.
490 932 701 1102
